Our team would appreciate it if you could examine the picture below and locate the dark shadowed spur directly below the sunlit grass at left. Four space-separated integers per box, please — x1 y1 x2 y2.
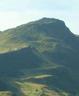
0 47 45 77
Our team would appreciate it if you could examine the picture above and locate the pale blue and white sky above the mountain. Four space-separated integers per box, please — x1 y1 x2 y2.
0 0 79 34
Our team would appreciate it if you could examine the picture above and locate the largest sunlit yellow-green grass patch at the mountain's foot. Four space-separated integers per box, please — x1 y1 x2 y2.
16 82 69 96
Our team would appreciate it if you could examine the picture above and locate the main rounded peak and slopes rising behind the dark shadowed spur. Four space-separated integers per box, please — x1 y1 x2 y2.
0 18 79 77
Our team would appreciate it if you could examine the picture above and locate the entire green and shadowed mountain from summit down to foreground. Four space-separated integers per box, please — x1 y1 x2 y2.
0 18 79 96
